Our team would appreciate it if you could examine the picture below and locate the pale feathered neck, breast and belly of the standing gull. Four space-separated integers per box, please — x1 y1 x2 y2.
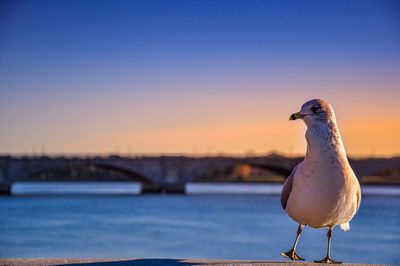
286 123 359 228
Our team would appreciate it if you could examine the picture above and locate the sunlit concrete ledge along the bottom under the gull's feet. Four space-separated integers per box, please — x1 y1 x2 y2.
0 259 378 266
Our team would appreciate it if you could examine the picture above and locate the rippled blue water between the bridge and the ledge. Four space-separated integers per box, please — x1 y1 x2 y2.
0 195 400 264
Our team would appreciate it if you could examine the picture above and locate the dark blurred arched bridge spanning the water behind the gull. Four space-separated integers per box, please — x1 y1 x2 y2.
0 154 400 192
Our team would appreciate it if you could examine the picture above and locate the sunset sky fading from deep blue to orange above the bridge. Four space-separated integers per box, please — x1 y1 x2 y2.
0 0 400 156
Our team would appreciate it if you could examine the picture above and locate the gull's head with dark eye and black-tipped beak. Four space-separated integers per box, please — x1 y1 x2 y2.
289 99 335 126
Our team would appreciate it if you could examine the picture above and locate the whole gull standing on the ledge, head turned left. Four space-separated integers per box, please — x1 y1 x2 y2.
281 99 361 263
